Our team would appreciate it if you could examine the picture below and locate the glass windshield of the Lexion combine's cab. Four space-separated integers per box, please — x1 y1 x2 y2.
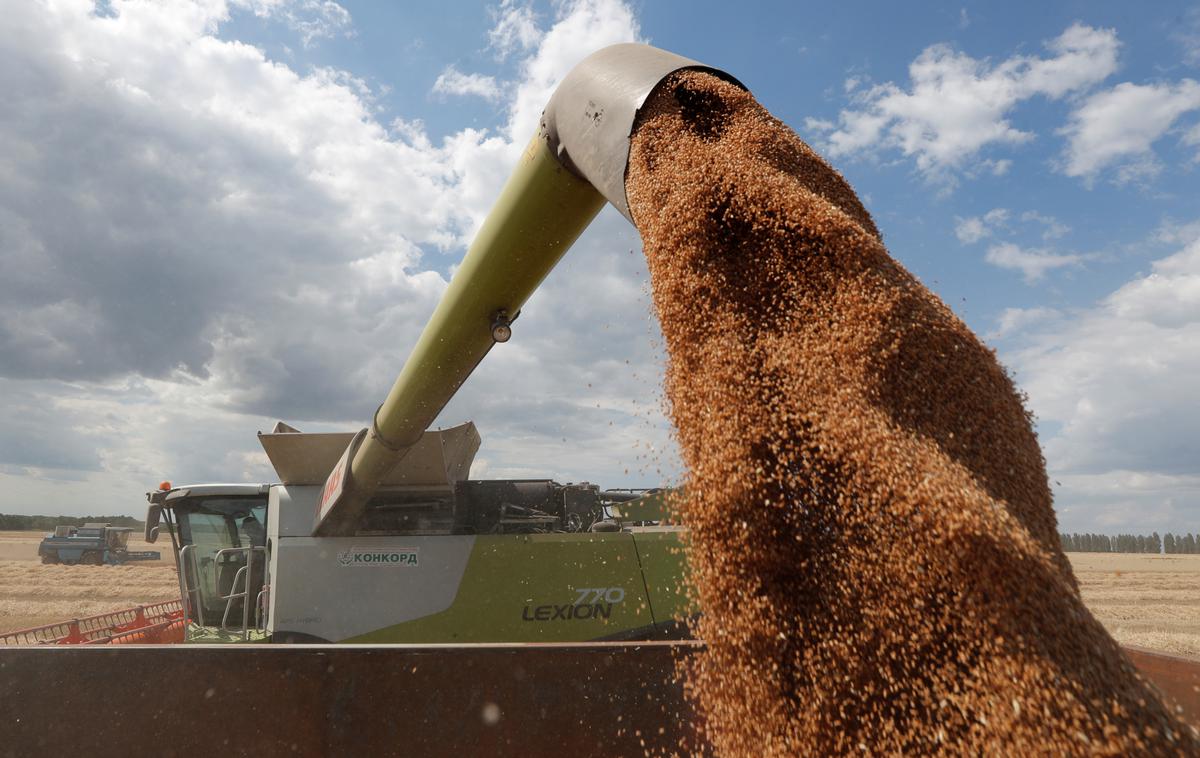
172 495 266 627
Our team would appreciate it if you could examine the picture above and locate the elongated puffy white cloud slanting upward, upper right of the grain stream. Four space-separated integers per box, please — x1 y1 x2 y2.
810 24 1118 182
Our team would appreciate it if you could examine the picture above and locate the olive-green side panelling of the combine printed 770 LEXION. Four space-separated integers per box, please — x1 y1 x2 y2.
346 531 683 643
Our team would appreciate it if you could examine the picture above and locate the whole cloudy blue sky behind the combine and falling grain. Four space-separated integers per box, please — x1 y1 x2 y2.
0 0 1200 533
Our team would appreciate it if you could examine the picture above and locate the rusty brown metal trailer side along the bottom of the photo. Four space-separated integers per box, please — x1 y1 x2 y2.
0 642 1200 758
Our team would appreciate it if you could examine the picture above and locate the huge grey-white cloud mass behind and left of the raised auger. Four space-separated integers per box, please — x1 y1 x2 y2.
0 0 672 512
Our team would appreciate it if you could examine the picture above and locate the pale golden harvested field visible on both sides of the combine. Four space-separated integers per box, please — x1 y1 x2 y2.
0 531 1200 657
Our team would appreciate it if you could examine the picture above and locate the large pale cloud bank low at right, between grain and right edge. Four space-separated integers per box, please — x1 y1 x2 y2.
1006 233 1200 531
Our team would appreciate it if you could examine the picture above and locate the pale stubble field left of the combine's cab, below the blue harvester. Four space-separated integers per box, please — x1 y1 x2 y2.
0 531 179 632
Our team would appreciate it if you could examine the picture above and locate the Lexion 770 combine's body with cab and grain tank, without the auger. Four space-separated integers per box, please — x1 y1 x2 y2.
148 423 686 643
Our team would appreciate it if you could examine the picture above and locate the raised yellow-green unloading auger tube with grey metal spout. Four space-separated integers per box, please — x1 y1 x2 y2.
313 43 744 536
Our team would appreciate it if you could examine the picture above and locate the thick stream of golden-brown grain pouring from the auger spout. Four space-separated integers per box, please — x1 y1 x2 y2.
626 72 1198 754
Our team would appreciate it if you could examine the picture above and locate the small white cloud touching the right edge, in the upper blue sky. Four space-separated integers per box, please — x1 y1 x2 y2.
1060 79 1200 181
